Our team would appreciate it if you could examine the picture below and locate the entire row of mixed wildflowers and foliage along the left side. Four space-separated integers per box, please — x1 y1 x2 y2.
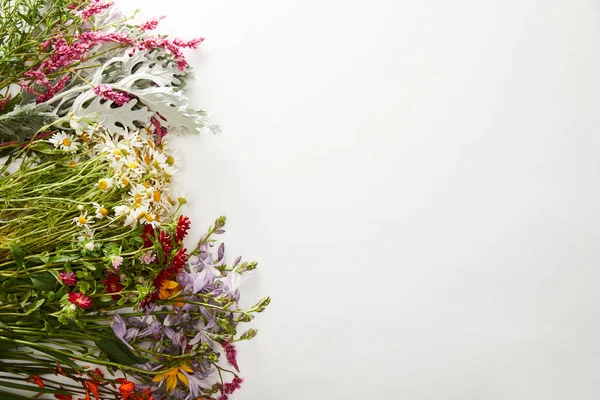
0 0 270 400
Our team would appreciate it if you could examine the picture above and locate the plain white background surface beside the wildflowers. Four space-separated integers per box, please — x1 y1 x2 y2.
119 0 600 400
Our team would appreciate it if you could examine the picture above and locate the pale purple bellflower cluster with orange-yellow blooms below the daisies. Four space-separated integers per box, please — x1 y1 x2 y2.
112 225 270 399
